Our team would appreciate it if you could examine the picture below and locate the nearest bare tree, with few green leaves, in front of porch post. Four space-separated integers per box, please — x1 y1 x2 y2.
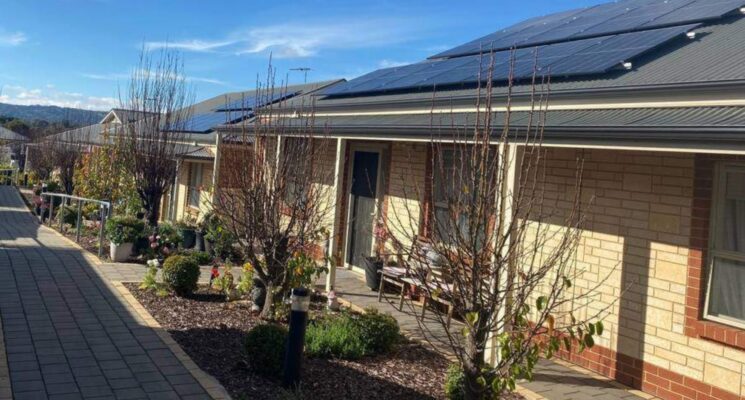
380 64 603 399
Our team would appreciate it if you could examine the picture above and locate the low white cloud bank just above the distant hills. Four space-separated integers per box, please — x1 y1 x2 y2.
0 85 119 110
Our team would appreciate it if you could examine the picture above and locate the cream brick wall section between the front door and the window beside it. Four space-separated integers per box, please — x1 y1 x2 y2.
386 142 427 250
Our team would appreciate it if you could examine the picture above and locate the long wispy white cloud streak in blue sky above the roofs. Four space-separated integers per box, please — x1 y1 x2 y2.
146 19 426 58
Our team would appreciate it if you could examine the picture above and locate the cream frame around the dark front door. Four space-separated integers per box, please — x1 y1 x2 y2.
342 143 388 272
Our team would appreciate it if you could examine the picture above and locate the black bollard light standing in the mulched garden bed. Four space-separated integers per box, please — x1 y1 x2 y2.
282 288 310 388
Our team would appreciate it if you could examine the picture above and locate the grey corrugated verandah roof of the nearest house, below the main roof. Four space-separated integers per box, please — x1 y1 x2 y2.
266 107 745 143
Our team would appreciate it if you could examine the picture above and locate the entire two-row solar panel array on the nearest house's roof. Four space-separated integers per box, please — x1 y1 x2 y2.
323 0 745 96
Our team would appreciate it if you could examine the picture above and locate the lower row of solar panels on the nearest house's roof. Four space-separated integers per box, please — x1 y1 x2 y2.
324 24 698 95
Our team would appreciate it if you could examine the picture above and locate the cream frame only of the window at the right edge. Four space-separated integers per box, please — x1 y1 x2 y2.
703 163 745 329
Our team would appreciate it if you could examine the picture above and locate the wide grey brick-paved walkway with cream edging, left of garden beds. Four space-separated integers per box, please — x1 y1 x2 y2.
0 186 209 400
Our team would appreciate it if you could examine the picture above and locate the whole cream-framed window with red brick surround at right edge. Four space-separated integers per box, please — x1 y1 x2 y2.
705 165 745 327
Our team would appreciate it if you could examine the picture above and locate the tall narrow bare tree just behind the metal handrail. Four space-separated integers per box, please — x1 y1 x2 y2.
119 49 193 226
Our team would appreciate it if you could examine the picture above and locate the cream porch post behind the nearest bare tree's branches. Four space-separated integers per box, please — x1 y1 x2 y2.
485 143 517 365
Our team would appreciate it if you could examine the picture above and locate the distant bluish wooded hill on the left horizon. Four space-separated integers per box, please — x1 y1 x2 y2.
0 103 106 126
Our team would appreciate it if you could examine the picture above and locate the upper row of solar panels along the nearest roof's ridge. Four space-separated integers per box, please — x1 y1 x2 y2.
430 0 745 59
